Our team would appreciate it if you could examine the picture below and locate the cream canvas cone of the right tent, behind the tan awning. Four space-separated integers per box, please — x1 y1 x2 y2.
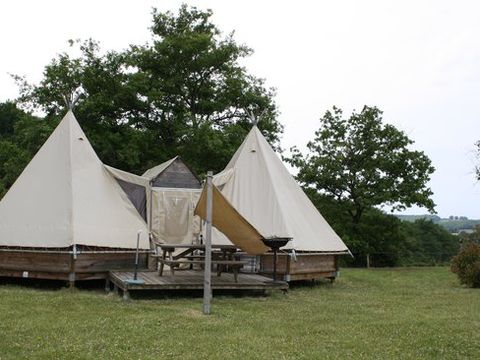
213 126 349 254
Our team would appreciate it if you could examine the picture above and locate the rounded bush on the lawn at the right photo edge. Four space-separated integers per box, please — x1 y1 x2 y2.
451 242 480 288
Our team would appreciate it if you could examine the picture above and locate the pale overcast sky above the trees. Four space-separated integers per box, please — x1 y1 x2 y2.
0 0 480 218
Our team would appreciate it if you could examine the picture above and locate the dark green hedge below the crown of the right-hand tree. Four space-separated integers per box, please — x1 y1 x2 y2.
304 187 459 267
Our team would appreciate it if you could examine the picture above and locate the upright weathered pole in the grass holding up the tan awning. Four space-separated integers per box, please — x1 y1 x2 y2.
203 171 213 315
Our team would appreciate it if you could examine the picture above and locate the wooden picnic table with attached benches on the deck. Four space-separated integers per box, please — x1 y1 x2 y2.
153 244 248 282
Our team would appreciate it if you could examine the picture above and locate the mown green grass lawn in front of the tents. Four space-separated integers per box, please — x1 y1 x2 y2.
0 267 480 360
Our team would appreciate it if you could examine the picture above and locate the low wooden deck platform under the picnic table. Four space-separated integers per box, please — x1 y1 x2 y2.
109 270 288 299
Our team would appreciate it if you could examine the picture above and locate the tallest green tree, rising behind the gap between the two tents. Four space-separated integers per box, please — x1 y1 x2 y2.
128 5 282 172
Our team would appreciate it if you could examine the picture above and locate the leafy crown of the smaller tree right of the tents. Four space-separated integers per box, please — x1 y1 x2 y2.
289 106 435 225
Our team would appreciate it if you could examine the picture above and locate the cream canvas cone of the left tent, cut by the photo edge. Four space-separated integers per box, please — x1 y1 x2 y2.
0 111 149 249
